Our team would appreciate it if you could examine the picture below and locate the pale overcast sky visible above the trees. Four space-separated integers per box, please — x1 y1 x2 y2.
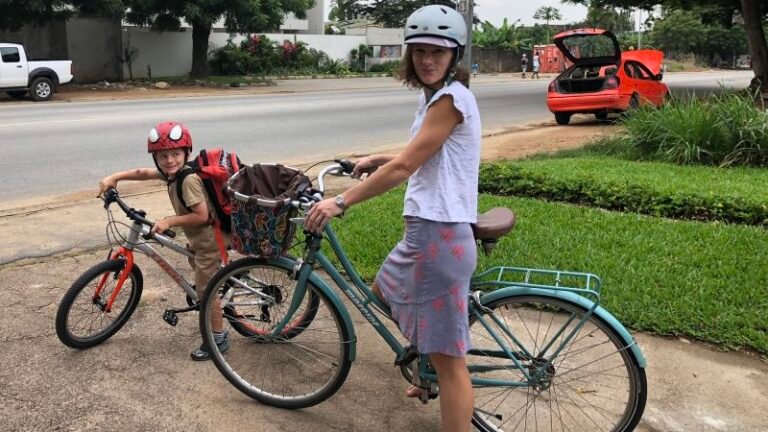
325 0 587 26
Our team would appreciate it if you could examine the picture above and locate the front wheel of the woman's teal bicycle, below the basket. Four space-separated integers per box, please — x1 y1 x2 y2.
200 258 351 409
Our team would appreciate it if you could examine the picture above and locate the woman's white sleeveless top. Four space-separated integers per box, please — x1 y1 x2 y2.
403 81 482 223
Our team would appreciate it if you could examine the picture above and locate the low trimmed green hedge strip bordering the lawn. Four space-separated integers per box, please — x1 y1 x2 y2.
480 157 768 226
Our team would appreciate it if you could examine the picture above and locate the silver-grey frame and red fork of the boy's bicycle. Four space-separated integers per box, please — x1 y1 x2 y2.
93 222 197 312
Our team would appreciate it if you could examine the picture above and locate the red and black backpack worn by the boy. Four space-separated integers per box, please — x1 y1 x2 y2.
176 148 240 233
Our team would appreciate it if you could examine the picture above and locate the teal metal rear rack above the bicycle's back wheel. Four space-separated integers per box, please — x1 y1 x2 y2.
471 266 602 303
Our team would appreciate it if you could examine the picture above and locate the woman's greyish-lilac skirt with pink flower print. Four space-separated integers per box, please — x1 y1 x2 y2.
376 216 477 357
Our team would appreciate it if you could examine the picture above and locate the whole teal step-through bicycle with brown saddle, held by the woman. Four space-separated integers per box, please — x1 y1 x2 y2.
200 161 647 432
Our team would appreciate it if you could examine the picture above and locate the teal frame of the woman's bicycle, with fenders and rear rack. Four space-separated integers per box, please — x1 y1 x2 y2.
249 159 646 394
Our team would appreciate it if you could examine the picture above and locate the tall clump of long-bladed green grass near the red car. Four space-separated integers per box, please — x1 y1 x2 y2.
621 93 768 166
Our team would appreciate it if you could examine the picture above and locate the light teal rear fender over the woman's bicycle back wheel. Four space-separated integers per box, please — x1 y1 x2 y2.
480 286 647 369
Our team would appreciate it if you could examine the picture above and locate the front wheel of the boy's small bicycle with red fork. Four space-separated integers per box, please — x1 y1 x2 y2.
56 260 143 349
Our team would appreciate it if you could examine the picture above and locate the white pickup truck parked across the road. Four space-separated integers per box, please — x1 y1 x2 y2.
0 43 72 102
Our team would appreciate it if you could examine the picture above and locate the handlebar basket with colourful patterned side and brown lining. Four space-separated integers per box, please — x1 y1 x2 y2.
226 164 311 258
